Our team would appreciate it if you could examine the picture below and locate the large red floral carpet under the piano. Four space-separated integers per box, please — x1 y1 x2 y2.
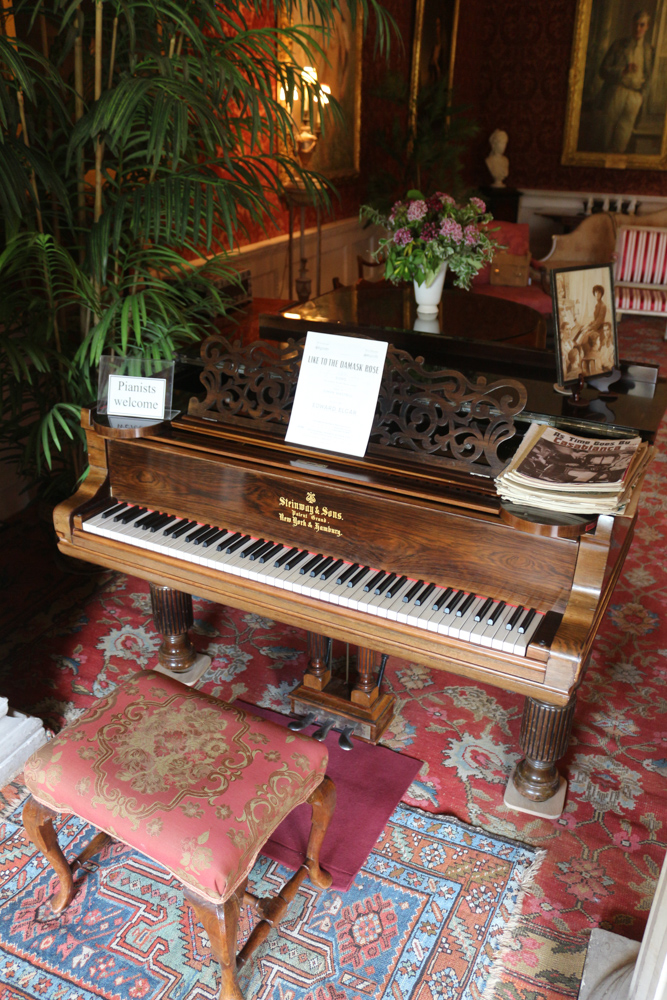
0 317 667 1000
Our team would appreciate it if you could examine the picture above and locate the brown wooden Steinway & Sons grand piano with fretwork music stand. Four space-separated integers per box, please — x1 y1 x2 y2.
54 289 667 816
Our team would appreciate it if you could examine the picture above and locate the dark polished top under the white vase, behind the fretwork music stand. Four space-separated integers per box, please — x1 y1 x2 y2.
258 285 667 440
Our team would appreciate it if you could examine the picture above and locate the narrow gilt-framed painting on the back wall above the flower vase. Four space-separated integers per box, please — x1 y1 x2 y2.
410 0 460 128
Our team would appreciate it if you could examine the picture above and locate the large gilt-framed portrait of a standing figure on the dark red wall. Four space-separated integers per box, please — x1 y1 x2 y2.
562 0 667 170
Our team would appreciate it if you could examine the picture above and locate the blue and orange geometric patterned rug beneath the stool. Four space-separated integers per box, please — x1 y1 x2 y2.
0 784 541 1000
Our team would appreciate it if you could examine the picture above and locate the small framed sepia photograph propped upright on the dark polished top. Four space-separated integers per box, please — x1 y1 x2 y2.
551 264 618 386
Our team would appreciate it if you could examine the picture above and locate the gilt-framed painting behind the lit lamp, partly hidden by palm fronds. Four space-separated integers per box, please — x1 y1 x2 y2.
278 4 363 179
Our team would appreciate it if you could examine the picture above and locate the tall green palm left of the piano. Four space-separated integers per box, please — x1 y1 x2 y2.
0 0 391 496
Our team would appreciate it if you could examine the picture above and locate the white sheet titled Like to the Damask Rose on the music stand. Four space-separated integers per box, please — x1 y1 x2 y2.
285 330 387 456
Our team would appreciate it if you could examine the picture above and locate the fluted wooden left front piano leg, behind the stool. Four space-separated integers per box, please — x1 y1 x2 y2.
150 583 211 684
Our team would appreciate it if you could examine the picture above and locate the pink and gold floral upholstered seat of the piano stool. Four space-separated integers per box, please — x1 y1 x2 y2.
25 671 328 903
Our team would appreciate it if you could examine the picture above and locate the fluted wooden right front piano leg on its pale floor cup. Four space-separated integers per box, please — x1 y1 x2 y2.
505 695 576 819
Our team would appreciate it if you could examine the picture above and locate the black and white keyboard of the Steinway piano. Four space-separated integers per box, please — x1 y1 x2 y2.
83 501 544 656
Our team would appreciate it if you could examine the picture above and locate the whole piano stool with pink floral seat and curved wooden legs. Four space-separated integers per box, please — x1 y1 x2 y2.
23 670 336 1000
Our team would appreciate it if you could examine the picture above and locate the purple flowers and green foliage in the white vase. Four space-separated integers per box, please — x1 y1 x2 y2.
361 191 498 288
